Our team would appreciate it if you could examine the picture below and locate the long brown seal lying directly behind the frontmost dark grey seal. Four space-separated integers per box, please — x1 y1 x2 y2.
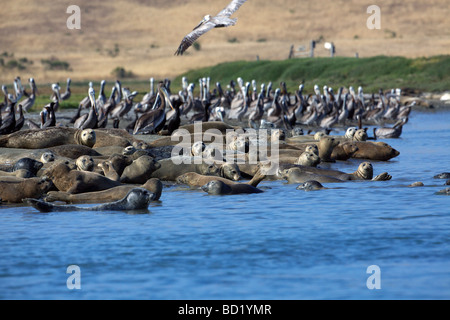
44 178 163 203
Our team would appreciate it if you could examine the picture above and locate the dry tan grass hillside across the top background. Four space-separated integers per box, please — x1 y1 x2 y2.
0 0 450 83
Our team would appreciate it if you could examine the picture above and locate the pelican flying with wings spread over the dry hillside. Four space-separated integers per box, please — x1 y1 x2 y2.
175 0 247 55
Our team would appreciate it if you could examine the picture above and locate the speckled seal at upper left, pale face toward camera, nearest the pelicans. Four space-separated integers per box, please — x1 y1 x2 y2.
0 127 96 149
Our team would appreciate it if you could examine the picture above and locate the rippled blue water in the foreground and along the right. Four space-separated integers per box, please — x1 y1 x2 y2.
0 111 450 299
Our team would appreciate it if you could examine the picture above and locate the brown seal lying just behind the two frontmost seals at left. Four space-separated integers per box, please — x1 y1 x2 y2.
43 161 120 193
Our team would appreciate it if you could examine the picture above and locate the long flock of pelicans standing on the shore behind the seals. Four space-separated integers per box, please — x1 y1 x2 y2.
0 77 415 139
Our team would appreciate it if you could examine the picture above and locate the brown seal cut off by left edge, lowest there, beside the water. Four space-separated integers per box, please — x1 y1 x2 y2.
0 177 53 203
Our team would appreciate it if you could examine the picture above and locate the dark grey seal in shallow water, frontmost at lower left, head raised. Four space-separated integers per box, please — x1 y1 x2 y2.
23 188 153 212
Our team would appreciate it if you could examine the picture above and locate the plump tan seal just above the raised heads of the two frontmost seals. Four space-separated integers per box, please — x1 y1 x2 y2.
120 156 161 184
